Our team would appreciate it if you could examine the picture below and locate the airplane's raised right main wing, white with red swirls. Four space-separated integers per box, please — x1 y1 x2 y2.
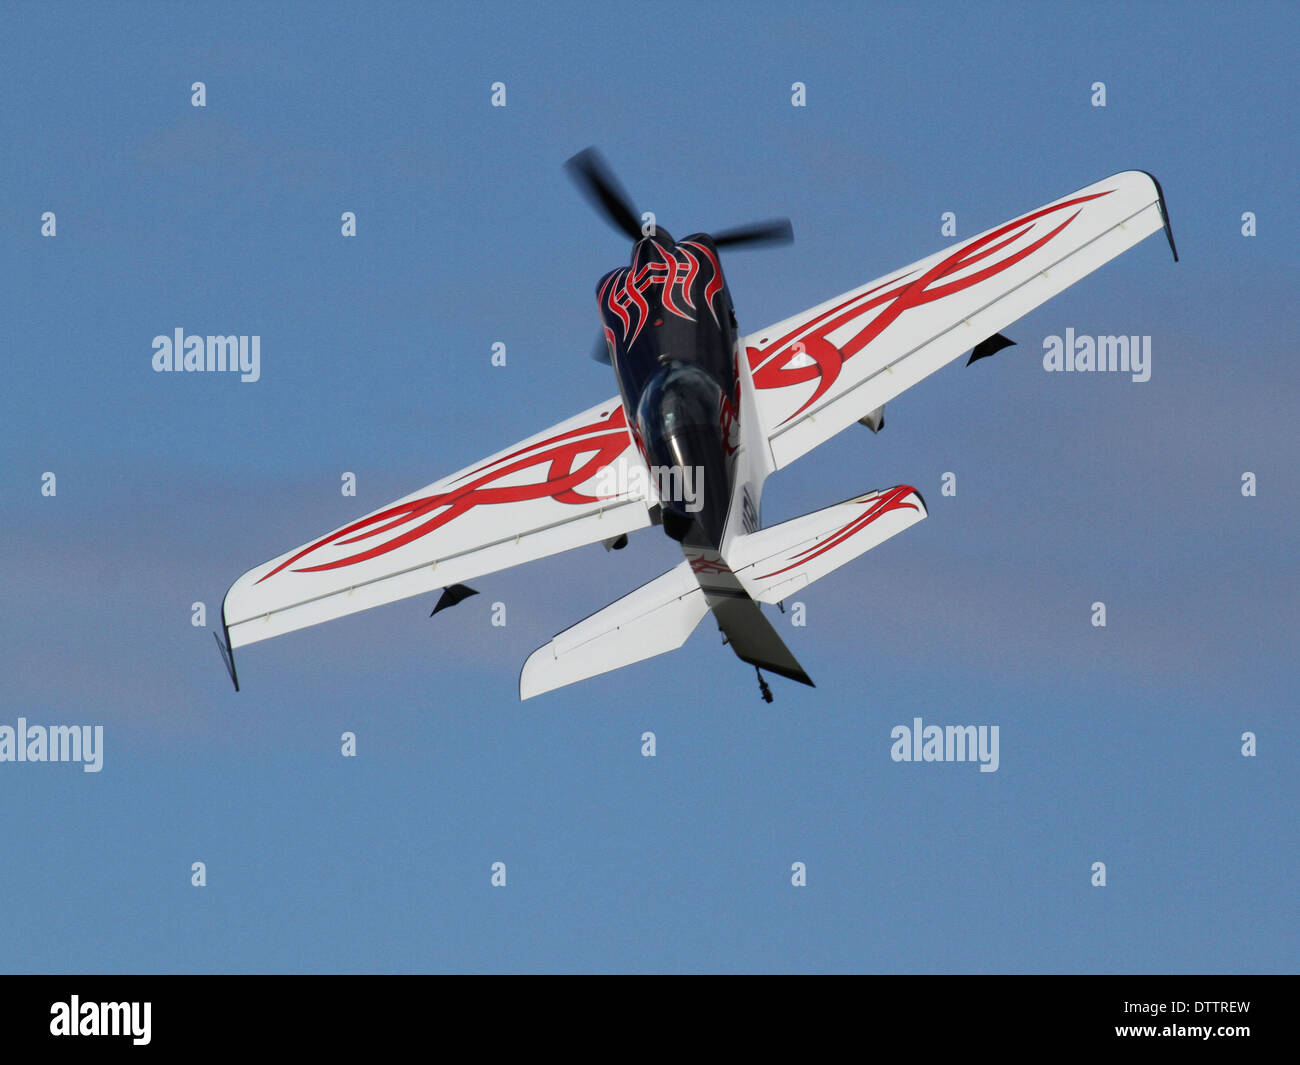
744 170 1178 469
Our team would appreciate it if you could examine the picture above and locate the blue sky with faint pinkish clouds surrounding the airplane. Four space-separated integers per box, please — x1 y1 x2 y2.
0 4 1300 973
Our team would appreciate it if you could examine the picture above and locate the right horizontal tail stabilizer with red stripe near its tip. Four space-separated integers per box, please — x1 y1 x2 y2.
727 485 927 603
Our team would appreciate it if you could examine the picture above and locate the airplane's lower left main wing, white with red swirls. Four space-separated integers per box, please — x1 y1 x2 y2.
222 399 660 649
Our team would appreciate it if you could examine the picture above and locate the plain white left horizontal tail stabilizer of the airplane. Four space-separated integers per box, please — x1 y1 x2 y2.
519 562 709 700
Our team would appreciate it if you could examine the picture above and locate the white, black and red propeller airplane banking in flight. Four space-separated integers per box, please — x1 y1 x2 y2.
216 148 1178 702
